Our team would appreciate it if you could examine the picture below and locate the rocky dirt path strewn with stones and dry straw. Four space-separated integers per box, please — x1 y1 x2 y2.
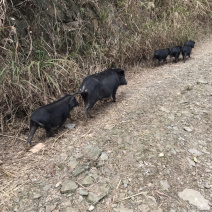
0 35 212 212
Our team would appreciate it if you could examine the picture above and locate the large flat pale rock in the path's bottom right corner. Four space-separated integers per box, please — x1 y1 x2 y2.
178 188 210 210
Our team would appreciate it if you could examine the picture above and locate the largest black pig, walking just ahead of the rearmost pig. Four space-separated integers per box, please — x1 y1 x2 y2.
78 68 127 121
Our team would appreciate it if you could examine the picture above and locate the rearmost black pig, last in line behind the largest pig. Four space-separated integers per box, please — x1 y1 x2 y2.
27 95 79 145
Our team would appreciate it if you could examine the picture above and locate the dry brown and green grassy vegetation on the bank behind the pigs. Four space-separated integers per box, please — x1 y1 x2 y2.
0 0 212 131
